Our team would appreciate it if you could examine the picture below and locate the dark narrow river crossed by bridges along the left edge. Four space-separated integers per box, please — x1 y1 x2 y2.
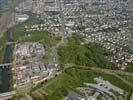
1 29 12 92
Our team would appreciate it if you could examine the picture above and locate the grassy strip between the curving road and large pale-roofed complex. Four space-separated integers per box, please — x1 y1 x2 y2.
31 68 132 100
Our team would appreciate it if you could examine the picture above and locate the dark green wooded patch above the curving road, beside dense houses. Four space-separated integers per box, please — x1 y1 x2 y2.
58 38 115 69
